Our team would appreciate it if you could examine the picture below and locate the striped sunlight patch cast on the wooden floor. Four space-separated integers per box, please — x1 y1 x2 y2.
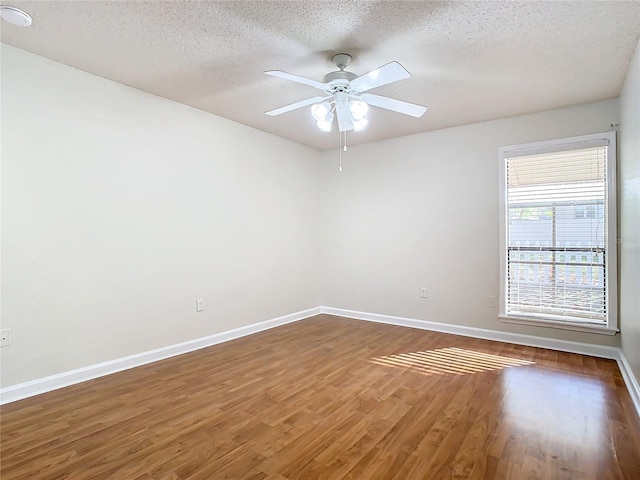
370 347 535 375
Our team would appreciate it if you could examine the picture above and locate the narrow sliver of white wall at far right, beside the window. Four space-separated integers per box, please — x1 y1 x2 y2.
618 37 640 381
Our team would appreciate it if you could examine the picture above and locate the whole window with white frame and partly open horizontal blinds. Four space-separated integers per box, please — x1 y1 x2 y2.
500 132 617 334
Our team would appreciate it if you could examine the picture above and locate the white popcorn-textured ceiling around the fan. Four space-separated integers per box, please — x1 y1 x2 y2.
1 0 640 150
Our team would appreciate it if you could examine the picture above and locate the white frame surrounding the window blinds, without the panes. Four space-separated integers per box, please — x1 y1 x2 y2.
498 131 619 335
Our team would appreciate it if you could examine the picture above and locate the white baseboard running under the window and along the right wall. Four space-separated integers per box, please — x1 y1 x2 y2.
320 307 640 417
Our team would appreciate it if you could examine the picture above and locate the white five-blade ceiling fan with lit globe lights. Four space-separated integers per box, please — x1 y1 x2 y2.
264 53 427 132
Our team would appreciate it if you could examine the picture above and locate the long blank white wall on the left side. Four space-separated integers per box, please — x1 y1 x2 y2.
0 45 319 386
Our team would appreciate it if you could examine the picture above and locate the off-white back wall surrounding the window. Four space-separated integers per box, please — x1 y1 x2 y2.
321 100 619 345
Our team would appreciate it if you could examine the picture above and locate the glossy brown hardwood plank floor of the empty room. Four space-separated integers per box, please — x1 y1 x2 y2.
0 315 640 480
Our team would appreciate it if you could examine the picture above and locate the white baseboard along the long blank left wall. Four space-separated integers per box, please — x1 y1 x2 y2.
0 307 320 405
